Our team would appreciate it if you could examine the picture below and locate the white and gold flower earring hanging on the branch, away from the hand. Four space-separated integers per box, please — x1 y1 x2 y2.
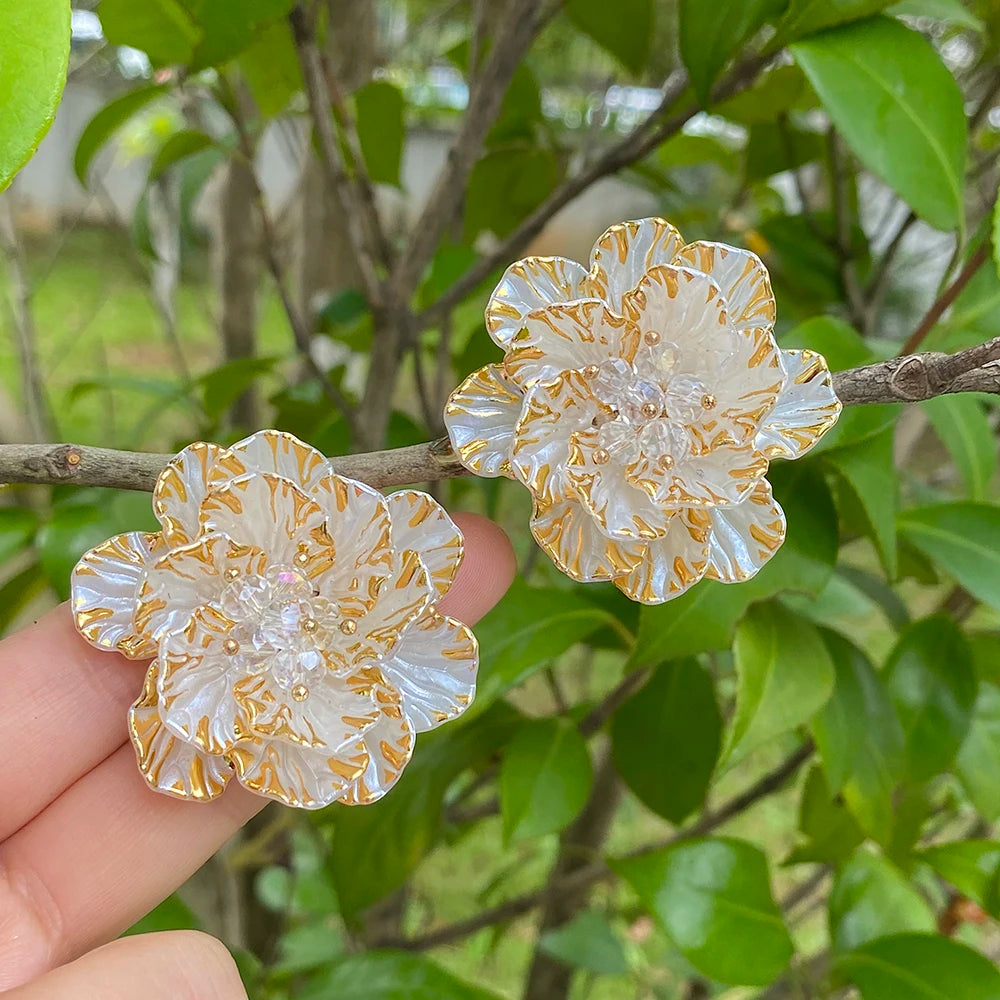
445 219 841 604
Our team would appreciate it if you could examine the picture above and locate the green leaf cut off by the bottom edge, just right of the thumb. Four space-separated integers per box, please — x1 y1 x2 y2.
295 951 498 1000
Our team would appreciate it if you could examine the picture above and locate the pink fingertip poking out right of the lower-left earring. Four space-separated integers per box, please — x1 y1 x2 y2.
440 512 517 625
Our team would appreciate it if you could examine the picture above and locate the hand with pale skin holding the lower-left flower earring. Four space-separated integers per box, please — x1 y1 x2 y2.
0 514 515 1000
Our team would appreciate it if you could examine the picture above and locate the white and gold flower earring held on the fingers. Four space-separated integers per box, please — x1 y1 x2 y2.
72 431 478 809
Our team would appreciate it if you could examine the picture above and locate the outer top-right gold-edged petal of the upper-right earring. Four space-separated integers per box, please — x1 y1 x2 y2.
671 240 777 331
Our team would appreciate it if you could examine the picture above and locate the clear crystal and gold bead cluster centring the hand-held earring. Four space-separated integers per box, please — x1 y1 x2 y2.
220 566 338 700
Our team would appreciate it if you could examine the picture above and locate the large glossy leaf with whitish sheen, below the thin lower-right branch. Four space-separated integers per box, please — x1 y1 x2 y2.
612 837 792 986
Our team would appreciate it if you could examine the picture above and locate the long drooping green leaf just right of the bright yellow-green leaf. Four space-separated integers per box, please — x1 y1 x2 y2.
812 631 905 843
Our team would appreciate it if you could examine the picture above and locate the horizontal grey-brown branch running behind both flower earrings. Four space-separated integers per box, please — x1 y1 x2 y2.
0 337 1000 492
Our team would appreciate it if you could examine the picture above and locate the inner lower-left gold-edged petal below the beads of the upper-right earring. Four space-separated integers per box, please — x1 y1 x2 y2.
566 427 674 542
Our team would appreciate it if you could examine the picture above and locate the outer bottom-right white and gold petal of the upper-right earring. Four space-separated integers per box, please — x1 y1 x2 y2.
704 479 785 583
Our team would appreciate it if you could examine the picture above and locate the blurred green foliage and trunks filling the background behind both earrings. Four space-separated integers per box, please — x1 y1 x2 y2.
0 0 1000 1000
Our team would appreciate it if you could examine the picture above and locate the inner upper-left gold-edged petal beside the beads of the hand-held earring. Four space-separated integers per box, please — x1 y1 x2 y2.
135 532 267 655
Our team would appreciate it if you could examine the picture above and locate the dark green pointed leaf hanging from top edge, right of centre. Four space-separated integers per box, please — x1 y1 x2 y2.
678 0 781 107
